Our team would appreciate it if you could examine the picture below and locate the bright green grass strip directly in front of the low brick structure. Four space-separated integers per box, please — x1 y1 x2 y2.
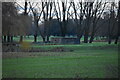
31 42 118 51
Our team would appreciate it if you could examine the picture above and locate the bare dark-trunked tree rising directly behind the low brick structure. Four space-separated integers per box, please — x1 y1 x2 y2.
54 0 69 37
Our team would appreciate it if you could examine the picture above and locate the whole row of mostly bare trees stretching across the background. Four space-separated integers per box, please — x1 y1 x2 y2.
2 0 120 44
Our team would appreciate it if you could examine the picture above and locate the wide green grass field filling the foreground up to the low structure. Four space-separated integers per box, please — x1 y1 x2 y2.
2 42 118 78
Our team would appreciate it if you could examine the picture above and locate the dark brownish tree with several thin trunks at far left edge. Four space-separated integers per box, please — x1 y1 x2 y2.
2 2 17 42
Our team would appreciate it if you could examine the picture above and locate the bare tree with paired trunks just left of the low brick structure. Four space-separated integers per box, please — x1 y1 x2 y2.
41 1 53 42
